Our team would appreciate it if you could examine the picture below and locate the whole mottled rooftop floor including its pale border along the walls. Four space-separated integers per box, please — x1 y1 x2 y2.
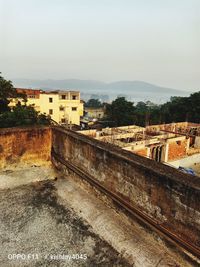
0 166 197 267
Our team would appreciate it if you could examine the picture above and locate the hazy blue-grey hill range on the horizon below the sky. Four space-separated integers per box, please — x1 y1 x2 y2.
13 79 189 102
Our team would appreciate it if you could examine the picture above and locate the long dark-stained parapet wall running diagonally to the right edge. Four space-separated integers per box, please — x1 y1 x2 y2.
52 128 200 249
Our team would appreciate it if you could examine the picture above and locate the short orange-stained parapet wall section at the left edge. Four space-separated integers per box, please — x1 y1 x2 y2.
0 127 51 168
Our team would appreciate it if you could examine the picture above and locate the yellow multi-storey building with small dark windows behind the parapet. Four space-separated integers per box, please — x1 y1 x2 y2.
9 88 83 125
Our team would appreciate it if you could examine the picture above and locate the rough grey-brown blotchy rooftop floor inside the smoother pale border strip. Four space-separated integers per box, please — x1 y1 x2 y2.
0 181 130 267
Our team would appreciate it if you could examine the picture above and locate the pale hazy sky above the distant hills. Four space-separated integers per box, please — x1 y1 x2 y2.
0 0 200 91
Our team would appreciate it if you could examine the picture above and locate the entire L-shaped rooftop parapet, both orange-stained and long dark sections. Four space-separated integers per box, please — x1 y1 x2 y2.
0 127 200 254
